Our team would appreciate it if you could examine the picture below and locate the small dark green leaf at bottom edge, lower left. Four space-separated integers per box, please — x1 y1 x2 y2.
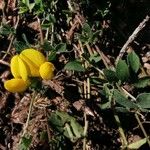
19 136 32 150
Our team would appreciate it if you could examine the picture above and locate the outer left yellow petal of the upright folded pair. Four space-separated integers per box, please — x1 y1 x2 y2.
10 55 21 78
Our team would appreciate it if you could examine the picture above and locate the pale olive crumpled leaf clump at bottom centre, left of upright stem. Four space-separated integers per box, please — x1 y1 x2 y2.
49 111 83 142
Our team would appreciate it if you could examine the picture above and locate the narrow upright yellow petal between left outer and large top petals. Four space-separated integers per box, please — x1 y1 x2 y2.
18 57 30 81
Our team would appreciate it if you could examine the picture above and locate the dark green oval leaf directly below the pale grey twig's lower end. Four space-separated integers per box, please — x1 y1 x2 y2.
116 60 129 82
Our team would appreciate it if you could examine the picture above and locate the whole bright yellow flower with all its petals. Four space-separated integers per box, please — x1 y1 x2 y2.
4 49 55 92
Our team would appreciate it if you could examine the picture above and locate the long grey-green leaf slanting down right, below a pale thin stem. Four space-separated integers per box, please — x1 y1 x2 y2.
113 89 138 109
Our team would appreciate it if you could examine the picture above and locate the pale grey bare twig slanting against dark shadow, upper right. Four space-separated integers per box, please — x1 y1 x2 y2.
116 16 150 63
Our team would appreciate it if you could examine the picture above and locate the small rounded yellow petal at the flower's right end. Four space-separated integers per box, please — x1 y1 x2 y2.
39 62 55 80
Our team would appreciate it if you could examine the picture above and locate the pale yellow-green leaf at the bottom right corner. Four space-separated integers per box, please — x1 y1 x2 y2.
128 138 147 150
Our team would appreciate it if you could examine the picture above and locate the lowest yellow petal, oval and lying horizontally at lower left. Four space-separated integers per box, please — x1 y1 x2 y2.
4 79 28 93
